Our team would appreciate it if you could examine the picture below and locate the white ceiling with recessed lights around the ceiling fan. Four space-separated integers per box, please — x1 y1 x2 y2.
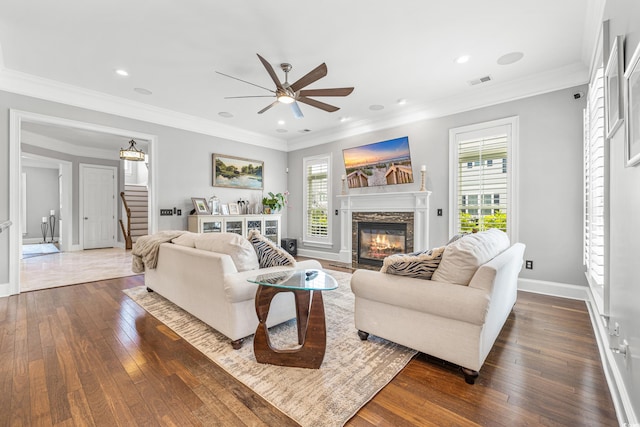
0 0 603 147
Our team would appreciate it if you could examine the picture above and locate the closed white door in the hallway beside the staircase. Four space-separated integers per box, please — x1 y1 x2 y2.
80 165 117 249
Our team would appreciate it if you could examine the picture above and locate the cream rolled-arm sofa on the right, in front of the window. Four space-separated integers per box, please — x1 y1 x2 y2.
351 232 525 384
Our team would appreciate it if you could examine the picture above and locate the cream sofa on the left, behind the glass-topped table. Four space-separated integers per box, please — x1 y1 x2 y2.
145 233 322 349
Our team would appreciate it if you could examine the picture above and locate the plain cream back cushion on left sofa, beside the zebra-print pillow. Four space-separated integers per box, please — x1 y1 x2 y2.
195 233 259 271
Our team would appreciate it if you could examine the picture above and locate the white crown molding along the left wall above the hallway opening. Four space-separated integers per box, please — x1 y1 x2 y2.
0 67 287 151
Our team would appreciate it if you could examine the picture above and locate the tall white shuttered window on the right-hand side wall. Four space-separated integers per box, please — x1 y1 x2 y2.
584 67 605 295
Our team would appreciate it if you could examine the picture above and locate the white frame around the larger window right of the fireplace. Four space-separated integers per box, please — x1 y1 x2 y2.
449 116 520 242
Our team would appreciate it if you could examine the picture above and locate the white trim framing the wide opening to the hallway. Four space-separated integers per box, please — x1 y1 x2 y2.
6 109 158 297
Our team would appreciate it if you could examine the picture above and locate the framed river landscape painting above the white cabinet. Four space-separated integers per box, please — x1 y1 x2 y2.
213 154 264 190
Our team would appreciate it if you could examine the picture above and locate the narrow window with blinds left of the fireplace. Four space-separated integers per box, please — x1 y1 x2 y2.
303 156 331 243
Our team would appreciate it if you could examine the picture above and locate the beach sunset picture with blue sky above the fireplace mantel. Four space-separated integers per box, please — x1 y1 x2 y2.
342 136 413 188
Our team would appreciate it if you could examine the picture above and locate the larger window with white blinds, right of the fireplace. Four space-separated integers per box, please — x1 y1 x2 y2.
450 117 517 239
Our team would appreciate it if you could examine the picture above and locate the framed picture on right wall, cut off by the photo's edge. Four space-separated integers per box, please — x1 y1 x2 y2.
624 40 640 166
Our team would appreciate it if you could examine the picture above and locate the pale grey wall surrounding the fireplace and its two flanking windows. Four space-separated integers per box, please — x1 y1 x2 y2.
286 87 586 285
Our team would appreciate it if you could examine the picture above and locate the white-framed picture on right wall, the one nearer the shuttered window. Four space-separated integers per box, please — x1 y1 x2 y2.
604 36 624 138
